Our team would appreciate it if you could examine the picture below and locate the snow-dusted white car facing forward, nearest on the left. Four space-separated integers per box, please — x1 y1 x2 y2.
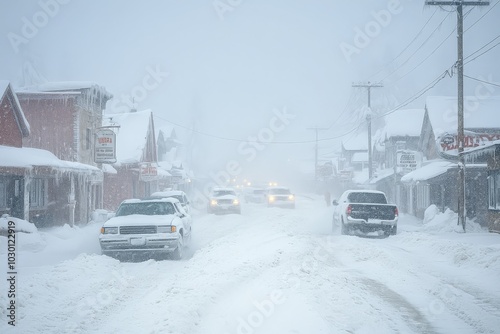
99 198 191 260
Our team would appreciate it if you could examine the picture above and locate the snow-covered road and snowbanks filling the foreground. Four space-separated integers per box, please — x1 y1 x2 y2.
0 196 500 334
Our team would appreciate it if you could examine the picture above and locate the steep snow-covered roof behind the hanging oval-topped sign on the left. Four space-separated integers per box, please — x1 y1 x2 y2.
103 109 151 164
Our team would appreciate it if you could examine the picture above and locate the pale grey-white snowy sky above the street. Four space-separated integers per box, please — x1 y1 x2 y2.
0 0 500 183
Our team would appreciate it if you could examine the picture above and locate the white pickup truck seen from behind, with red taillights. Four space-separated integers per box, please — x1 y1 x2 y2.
332 190 399 236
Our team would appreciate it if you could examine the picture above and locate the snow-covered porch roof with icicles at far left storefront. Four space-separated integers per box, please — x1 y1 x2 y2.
0 145 100 174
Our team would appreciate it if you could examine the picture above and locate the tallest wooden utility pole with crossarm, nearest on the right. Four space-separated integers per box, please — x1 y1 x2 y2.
425 0 490 232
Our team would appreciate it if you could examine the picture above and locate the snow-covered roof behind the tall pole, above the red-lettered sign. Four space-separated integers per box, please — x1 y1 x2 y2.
425 96 500 137
